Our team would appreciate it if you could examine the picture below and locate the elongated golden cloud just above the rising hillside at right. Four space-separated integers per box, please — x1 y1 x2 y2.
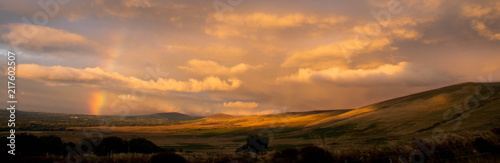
276 62 453 86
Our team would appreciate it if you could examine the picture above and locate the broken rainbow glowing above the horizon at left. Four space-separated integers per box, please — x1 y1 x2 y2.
87 28 127 115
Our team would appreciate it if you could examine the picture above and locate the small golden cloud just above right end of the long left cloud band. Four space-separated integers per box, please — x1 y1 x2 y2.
179 59 262 75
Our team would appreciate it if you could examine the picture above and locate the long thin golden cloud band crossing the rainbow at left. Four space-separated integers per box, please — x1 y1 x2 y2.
18 64 241 92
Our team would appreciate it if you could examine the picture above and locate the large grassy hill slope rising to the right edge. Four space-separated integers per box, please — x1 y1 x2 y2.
291 83 500 144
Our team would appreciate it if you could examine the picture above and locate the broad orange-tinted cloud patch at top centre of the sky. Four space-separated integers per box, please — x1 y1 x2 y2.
205 12 347 39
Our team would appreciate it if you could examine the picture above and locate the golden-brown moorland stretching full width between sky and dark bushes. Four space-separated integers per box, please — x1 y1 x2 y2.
2 83 500 162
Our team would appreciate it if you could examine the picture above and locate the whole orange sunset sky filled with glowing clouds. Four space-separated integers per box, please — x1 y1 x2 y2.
0 0 500 116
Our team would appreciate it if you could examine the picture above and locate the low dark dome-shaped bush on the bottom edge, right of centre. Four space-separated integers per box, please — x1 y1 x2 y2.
300 146 333 162
